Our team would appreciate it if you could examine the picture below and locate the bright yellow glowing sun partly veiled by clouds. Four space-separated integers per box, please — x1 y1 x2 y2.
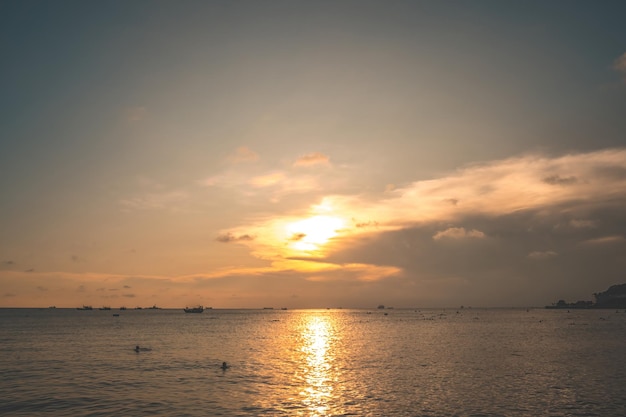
287 215 345 252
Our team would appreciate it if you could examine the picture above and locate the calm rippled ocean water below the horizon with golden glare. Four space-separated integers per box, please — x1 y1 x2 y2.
0 308 626 417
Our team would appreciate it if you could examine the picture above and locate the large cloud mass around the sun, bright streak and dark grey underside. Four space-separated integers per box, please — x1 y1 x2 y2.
210 148 626 306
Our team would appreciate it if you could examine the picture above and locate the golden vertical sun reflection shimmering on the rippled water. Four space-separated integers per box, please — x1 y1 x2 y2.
300 315 334 416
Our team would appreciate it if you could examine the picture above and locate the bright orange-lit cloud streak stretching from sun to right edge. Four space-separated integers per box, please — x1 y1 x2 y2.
325 149 626 230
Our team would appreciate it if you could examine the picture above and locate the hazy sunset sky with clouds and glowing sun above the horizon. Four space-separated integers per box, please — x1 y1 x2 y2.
0 0 626 308
